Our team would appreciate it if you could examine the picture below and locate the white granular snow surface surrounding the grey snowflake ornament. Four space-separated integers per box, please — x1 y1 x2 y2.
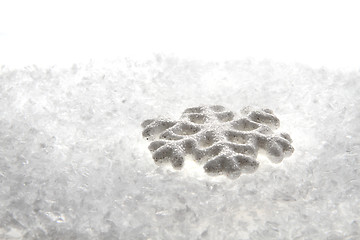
0 56 360 240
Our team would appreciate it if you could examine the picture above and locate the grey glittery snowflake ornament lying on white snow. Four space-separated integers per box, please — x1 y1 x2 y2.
142 105 294 178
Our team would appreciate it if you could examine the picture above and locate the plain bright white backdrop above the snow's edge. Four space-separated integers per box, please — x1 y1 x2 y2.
0 0 360 70
